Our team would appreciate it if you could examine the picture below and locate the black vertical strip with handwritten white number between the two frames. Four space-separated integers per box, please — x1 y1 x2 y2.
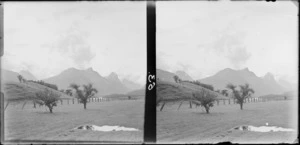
144 1 156 143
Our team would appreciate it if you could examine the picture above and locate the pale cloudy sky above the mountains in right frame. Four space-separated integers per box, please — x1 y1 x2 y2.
156 1 298 82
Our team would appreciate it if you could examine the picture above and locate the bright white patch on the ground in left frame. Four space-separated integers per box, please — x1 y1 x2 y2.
75 125 138 132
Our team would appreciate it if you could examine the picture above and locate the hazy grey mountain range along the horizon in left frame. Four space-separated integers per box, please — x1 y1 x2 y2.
1 68 142 95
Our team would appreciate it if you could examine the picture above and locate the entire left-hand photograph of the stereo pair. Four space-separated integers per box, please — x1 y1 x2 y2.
1 1 147 143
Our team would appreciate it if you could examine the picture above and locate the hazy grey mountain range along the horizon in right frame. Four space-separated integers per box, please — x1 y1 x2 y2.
157 68 293 96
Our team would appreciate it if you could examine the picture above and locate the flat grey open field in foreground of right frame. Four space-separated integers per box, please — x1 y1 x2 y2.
157 100 298 143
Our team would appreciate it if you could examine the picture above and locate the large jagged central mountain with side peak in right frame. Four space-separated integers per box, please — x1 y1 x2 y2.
199 68 284 96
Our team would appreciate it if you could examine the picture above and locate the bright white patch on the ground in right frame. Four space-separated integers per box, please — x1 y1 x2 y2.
234 125 295 132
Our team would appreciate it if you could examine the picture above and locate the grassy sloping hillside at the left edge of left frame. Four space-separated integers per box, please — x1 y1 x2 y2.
2 82 72 102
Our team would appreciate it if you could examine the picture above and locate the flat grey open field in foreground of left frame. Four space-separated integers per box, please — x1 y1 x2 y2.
4 99 144 142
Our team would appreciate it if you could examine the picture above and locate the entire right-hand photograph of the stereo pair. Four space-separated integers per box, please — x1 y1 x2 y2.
156 1 299 143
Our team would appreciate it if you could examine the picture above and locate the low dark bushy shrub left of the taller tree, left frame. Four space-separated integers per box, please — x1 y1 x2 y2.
34 89 60 113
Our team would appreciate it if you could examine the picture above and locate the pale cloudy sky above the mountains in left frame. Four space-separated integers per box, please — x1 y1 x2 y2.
1 2 147 84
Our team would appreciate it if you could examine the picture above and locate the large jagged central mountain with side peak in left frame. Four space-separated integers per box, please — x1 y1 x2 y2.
44 68 129 95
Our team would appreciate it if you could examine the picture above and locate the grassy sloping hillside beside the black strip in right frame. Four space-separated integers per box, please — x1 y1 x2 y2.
156 81 228 101
